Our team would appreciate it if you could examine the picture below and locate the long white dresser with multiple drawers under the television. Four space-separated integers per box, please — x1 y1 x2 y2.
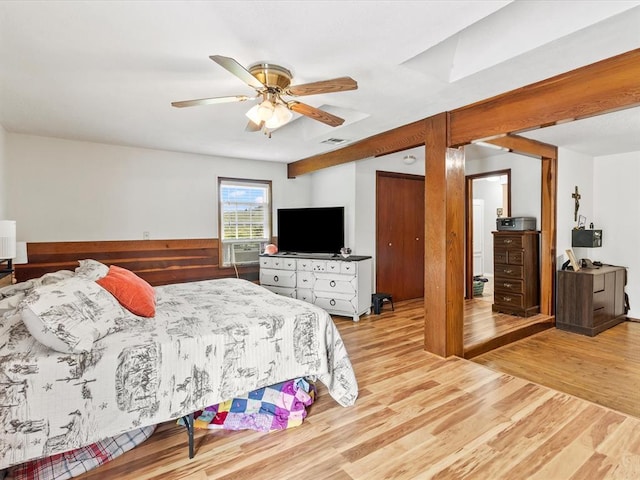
260 254 372 322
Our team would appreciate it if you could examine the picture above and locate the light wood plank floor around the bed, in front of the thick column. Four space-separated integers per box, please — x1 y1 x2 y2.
79 301 640 480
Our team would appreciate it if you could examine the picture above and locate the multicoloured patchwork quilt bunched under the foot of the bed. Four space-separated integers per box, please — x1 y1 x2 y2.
178 378 316 432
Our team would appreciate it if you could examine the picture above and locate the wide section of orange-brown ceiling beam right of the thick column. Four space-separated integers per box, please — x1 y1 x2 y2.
449 49 640 147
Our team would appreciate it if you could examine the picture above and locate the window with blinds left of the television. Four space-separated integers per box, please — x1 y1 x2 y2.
218 178 271 267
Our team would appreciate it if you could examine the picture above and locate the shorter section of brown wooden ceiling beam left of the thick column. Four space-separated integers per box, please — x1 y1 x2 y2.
287 120 426 178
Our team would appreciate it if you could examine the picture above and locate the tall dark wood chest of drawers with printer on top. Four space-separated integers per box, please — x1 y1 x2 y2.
492 230 540 317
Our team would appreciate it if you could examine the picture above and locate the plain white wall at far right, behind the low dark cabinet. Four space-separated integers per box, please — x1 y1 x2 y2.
592 152 640 318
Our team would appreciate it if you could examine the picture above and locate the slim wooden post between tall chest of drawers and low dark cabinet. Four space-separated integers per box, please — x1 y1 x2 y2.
540 156 558 315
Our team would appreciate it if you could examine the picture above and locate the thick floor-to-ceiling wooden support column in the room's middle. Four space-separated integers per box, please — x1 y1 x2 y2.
424 113 465 357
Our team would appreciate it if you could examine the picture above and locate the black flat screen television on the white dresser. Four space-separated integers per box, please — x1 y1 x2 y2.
278 207 344 254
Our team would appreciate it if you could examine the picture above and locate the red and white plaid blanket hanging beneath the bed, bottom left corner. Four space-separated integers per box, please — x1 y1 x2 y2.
0 425 156 480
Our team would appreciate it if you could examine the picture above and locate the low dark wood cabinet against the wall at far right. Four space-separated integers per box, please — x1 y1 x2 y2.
556 265 627 337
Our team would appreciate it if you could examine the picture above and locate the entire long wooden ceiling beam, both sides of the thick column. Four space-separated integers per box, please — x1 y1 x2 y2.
287 49 640 178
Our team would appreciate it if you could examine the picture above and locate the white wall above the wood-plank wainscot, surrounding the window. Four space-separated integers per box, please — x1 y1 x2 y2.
5 133 311 242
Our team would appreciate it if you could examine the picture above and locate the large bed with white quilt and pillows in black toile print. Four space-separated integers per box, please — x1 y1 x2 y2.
0 261 358 470
